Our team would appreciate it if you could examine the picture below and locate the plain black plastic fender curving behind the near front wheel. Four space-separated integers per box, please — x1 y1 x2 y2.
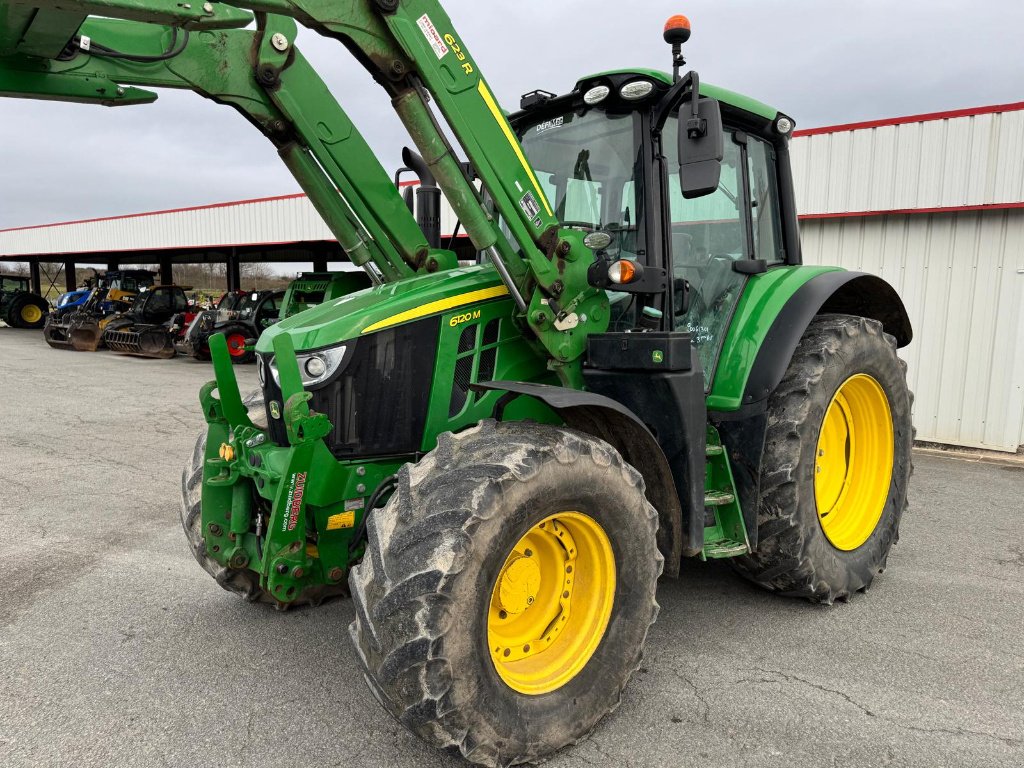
473 381 683 579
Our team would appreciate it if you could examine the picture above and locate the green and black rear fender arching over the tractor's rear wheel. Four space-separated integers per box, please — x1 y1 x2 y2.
708 266 913 412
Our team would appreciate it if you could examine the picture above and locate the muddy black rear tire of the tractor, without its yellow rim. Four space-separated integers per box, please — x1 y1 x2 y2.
730 314 913 603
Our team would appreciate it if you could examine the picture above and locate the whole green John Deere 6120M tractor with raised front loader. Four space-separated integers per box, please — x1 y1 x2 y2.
0 0 912 766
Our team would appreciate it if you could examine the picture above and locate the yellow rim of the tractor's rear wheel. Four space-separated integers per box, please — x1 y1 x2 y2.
814 374 894 551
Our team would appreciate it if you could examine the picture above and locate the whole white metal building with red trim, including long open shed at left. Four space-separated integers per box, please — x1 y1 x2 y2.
0 102 1024 452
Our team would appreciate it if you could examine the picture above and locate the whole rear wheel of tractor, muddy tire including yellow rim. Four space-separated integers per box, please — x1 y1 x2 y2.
730 314 913 603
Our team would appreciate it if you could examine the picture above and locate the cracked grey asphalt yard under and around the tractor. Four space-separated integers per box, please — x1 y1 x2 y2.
0 328 1024 768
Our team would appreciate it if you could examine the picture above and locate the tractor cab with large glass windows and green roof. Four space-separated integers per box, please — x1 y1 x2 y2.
511 70 800 387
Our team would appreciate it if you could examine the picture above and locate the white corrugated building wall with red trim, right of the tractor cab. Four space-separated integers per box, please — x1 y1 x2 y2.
793 102 1024 452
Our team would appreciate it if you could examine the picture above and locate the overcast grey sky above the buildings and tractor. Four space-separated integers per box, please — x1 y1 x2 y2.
0 0 1024 228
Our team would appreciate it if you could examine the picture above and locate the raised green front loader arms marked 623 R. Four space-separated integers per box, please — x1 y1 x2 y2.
0 0 608 388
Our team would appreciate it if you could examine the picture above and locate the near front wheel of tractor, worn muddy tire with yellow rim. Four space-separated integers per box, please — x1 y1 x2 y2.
349 422 663 766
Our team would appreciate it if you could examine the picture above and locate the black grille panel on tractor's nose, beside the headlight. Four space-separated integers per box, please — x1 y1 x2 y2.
264 317 439 459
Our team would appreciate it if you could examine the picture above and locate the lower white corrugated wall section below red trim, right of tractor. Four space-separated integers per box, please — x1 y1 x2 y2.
801 207 1024 451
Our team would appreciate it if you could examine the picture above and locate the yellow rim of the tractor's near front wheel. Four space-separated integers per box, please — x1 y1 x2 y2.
487 512 615 695
